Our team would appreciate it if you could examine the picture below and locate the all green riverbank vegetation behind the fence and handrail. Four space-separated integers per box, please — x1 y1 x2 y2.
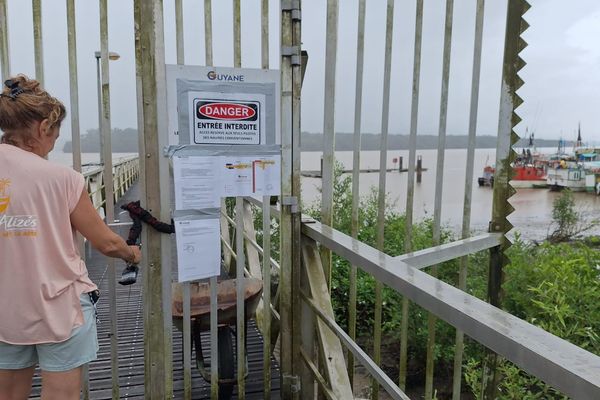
304 161 600 400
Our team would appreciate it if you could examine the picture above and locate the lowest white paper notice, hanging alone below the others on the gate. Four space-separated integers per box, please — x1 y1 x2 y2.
175 218 221 282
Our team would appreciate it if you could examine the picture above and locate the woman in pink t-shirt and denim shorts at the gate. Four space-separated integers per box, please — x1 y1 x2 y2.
0 75 141 400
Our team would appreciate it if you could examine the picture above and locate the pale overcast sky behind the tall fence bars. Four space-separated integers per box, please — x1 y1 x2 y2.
8 0 600 147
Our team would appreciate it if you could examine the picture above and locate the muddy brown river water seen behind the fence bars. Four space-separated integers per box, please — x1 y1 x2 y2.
49 149 600 241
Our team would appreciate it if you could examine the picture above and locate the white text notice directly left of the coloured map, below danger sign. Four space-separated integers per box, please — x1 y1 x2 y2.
173 157 221 210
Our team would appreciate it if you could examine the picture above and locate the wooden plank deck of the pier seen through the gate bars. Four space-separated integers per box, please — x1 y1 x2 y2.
30 184 280 400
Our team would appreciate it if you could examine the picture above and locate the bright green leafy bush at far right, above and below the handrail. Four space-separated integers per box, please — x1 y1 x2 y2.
465 240 600 400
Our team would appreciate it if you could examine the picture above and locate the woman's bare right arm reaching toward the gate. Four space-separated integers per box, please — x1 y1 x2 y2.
71 189 142 264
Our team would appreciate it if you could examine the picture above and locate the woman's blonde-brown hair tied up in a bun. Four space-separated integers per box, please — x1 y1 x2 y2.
0 74 67 144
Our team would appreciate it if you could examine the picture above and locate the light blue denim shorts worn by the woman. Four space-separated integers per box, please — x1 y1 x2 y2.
0 293 98 372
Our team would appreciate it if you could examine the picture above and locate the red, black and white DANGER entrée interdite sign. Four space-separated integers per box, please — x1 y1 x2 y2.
193 98 263 144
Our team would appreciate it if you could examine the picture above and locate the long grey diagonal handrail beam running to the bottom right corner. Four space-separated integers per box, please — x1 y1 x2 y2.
302 222 600 399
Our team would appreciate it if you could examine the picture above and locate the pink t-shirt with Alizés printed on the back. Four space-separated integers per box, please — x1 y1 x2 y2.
0 144 96 345
